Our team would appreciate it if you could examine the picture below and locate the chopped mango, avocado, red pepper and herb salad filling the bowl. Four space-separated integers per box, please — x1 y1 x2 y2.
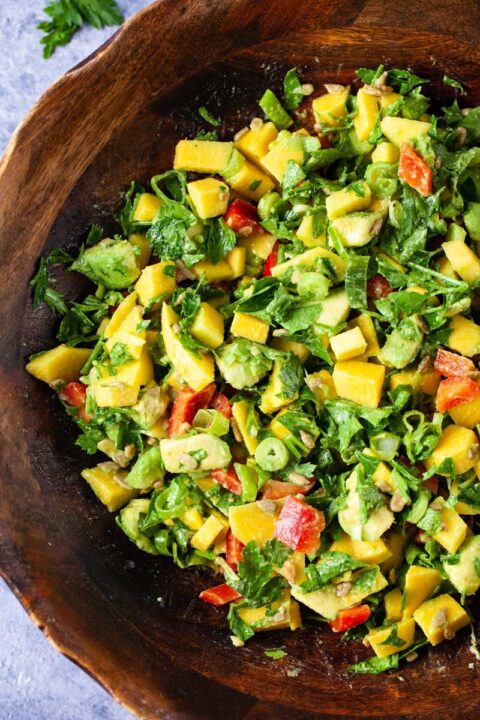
27 66 480 673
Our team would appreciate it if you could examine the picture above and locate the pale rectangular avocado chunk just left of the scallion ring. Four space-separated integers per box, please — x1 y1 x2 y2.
160 433 232 473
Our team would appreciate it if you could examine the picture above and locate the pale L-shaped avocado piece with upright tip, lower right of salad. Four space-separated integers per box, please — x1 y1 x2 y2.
338 470 394 541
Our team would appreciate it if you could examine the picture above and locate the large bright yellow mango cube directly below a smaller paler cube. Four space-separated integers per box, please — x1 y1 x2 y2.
332 360 385 408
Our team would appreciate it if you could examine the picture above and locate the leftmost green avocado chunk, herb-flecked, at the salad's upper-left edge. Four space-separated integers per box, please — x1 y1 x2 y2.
70 238 140 290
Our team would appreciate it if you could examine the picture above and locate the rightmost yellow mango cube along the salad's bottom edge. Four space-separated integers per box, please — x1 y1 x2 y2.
413 594 471 645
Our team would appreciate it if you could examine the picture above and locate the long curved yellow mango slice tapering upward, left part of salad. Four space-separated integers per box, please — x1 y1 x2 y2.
162 303 215 391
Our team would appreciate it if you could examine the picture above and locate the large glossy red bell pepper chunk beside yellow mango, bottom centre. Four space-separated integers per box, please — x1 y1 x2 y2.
275 495 325 554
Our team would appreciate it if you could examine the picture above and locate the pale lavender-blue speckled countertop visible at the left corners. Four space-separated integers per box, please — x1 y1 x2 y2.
0 0 149 720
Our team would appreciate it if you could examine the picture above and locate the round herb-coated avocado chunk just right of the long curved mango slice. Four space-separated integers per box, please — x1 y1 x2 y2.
216 338 273 390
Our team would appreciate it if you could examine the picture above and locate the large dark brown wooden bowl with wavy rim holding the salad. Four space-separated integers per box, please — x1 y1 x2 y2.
0 0 480 720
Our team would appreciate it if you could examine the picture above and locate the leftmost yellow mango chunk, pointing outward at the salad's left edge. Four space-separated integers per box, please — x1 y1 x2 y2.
25 345 92 385
